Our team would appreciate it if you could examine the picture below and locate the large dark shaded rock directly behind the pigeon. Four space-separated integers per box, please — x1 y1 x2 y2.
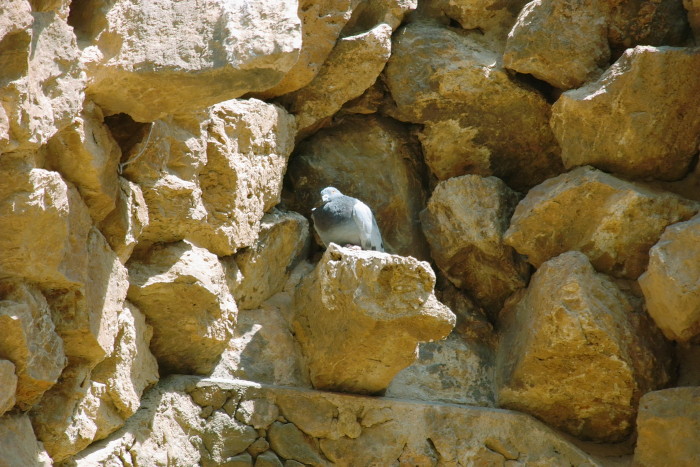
287 116 429 259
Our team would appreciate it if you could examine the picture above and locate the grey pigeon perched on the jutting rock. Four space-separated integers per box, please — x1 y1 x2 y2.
311 186 384 252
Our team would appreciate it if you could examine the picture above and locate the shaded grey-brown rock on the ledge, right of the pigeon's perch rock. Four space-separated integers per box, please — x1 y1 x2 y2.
385 332 495 407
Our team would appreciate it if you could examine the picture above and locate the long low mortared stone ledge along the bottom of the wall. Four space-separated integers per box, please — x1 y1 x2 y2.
65 376 603 466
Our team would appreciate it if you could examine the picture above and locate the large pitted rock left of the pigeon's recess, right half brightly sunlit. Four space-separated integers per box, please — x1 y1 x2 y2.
124 99 296 256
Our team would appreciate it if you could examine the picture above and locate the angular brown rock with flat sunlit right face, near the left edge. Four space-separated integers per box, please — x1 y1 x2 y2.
47 228 129 366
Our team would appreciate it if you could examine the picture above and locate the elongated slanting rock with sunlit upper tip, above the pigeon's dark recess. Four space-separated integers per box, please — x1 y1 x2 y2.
283 23 393 138
